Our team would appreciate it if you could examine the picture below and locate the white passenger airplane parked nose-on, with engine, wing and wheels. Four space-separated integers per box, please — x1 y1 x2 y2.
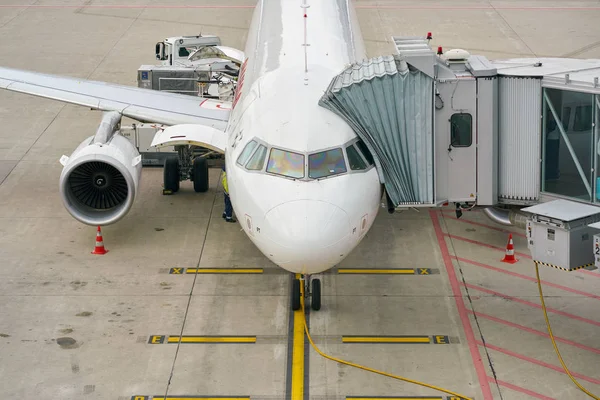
0 0 382 310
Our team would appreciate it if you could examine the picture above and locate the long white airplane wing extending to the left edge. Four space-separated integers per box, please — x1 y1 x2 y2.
0 67 231 131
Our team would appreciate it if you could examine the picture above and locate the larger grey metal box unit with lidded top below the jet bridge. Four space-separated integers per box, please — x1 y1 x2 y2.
522 200 600 271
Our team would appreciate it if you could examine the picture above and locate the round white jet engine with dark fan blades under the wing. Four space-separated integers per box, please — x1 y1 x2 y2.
59 112 142 226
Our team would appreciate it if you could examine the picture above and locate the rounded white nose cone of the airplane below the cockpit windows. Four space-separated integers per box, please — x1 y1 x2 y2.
265 200 350 273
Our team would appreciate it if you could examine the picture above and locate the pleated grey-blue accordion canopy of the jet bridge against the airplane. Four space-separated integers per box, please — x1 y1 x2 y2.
319 55 434 206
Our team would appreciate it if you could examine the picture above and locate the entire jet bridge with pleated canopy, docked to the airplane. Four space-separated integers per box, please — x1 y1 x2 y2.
319 37 600 220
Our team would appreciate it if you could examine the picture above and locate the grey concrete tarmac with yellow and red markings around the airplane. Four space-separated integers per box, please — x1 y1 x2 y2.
0 0 600 400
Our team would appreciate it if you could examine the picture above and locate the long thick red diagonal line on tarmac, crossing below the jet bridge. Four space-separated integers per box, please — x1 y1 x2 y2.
429 210 494 400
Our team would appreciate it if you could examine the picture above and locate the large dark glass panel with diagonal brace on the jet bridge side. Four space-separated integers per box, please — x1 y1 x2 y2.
543 89 595 201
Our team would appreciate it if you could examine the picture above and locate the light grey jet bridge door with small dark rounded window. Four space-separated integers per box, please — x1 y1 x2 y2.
435 74 477 202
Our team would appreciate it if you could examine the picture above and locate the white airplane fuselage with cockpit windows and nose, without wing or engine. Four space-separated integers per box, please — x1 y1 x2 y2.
225 0 381 274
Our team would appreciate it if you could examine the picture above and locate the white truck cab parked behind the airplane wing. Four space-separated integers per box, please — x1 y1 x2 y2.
156 35 221 65
